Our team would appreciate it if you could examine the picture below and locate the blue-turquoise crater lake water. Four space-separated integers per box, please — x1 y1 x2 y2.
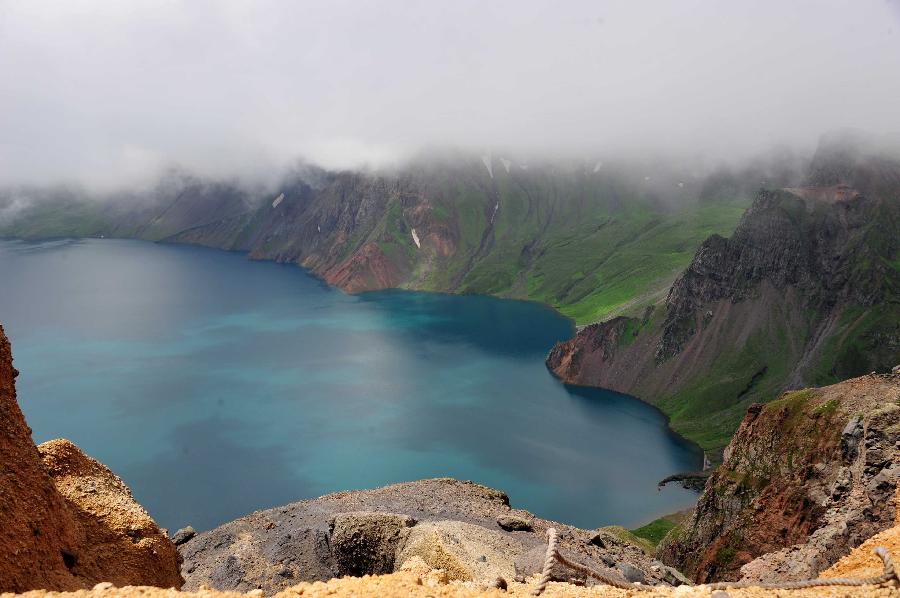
0 240 700 529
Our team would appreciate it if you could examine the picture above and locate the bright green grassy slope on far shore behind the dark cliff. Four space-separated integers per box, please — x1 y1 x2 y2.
463 200 747 324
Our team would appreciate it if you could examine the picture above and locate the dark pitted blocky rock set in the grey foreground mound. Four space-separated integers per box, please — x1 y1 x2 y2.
330 512 416 576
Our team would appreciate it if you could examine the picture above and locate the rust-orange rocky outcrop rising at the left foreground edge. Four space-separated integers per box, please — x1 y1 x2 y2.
0 327 182 592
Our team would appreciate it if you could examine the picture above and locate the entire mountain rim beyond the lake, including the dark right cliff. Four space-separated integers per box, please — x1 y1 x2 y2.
0 137 900 449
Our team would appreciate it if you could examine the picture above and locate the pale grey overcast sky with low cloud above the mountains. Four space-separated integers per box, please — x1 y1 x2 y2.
0 0 900 185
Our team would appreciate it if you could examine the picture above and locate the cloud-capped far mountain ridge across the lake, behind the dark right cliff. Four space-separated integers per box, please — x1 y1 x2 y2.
0 154 798 324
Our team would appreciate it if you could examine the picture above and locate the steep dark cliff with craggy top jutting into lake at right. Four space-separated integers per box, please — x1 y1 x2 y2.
547 141 900 448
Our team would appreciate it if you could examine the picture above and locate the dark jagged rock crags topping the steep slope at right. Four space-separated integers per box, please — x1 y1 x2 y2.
656 187 897 362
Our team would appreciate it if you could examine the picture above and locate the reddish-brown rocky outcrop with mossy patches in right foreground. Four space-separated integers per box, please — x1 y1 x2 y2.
659 374 900 582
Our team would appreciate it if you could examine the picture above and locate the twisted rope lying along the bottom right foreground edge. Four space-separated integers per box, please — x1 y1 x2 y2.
531 527 900 596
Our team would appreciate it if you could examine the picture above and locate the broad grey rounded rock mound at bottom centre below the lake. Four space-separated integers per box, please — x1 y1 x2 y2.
179 478 677 594
